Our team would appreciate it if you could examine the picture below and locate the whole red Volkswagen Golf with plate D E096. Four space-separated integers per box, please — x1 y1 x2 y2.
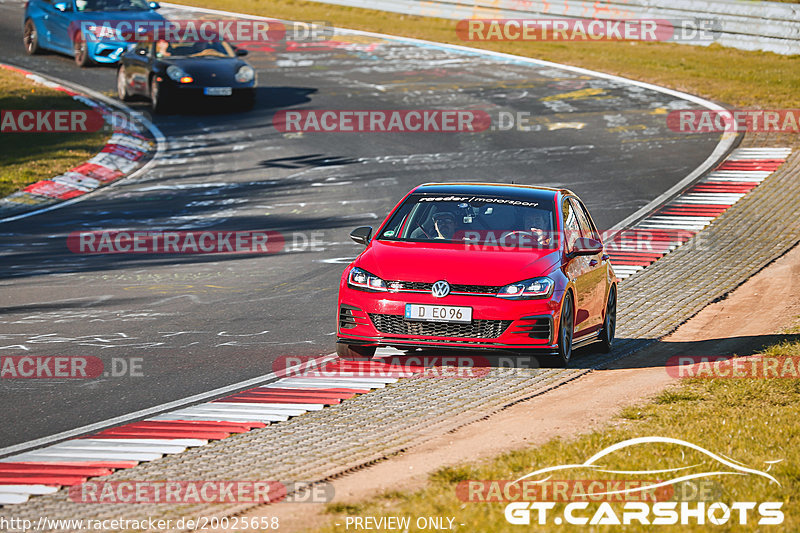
337 183 617 366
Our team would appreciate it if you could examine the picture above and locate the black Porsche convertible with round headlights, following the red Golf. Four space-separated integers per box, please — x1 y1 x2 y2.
117 40 257 113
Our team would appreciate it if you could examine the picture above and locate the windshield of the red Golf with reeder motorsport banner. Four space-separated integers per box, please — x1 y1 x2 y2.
378 194 558 248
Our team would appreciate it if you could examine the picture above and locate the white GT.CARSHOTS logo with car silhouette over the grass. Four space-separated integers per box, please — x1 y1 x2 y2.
500 437 784 526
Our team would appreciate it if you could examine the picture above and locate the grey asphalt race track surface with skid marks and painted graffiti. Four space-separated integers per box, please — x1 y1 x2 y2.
0 2 718 447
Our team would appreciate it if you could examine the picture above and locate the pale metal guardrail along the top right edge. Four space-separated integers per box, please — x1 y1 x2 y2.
315 0 800 55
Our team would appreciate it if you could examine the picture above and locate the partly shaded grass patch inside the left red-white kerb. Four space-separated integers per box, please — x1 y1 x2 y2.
0 69 108 198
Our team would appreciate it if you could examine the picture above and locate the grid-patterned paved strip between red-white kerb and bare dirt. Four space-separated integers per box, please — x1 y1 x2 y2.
0 135 800 523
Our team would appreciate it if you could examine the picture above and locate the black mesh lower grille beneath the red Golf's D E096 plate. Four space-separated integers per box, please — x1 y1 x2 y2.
369 313 511 339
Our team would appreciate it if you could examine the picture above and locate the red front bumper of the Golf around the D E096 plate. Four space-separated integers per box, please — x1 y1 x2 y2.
337 287 563 353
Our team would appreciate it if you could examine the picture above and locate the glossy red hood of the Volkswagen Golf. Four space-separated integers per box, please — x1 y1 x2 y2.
355 241 561 285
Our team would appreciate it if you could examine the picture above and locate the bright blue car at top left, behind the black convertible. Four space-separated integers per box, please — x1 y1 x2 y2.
22 0 165 67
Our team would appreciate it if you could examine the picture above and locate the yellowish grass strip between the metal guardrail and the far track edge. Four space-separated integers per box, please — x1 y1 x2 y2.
186 0 800 109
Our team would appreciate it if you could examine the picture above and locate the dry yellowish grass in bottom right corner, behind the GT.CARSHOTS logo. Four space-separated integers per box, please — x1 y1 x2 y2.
319 336 800 533
